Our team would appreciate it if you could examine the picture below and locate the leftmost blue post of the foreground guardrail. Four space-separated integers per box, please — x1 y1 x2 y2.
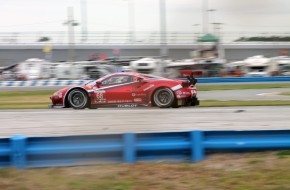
10 135 27 169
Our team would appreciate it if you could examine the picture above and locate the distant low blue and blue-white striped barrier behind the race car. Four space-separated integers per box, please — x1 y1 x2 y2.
0 76 290 87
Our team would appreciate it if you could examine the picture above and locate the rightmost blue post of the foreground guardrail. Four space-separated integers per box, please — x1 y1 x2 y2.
190 131 204 162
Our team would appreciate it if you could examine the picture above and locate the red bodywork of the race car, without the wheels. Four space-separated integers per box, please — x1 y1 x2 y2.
50 72 197 107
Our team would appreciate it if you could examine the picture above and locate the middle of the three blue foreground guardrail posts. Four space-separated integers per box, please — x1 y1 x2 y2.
123 133 136 163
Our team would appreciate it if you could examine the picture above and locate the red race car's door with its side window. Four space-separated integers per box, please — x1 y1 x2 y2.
97 75 134 104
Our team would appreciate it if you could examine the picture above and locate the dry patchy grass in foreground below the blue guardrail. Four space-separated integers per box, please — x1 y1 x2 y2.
0 152 290 190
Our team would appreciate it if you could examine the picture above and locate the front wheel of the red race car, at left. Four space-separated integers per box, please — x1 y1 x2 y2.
68 89 88 109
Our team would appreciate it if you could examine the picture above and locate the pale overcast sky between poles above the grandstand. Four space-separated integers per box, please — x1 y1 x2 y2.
0 0 290 33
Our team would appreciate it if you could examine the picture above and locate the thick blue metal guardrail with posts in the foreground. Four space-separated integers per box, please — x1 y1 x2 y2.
0 130 290 169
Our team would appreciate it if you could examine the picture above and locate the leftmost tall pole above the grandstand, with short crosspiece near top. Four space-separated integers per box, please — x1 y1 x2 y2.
64 7 78 62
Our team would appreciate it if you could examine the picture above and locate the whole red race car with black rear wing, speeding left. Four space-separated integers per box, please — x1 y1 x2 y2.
50 72 199 109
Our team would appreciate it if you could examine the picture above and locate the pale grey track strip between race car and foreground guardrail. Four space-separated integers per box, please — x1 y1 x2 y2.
0 106 290 138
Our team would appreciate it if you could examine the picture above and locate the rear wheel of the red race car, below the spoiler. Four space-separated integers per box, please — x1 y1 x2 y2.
153 88 175 108
